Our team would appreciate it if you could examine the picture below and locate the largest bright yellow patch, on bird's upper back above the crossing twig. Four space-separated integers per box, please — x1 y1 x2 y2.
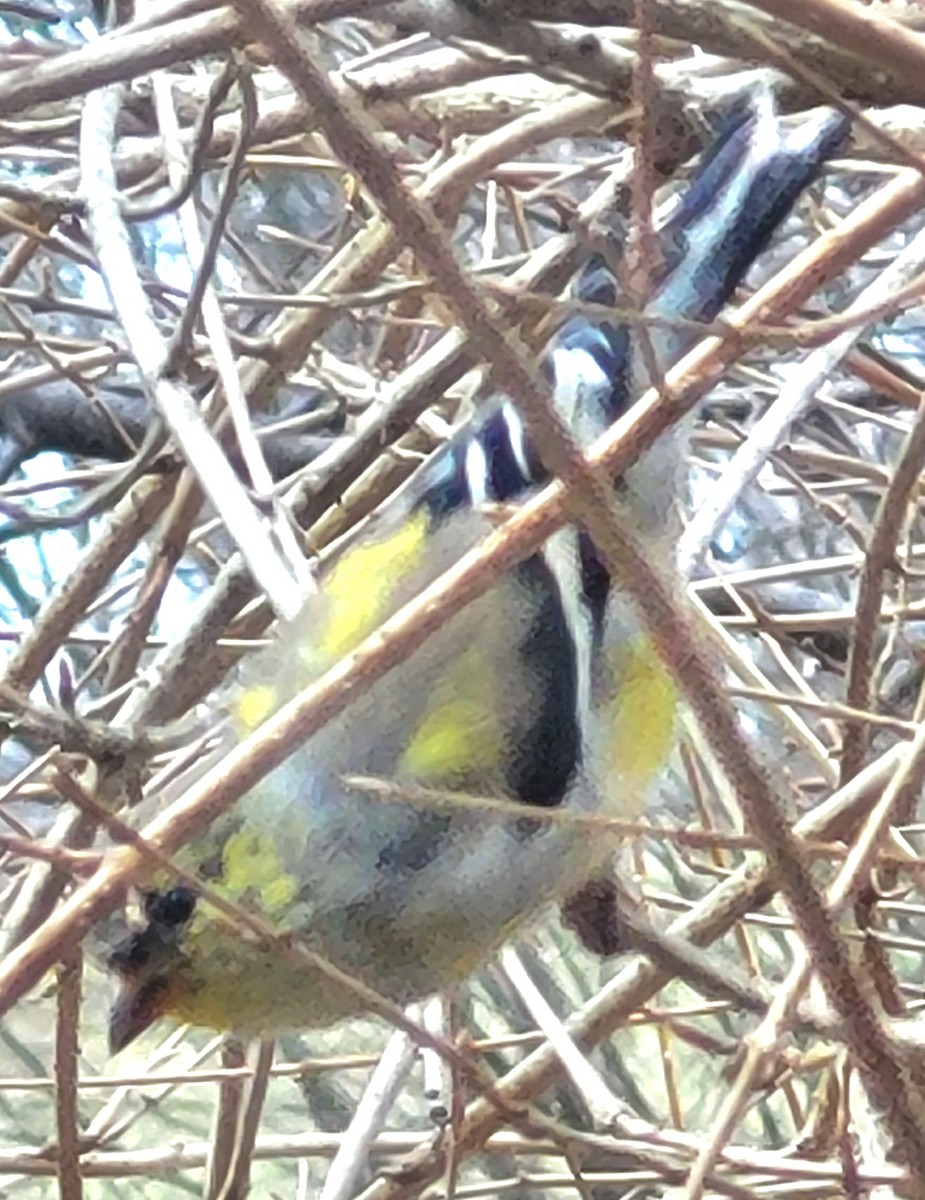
314 512 427 660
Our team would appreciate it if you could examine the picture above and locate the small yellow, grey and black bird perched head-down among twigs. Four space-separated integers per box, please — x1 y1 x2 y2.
108 97 848 1051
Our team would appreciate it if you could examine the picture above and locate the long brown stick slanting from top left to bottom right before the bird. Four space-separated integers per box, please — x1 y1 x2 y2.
235 0 925 1185
